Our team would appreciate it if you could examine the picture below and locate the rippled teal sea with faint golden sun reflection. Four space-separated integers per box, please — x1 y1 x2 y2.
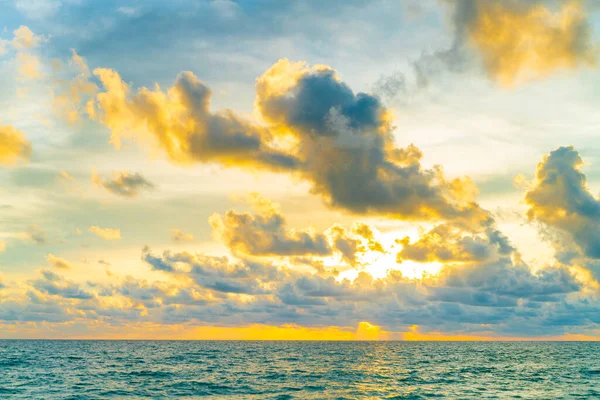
0 340 600 399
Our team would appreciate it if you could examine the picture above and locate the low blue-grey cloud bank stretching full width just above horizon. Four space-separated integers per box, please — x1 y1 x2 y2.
0 241 588 337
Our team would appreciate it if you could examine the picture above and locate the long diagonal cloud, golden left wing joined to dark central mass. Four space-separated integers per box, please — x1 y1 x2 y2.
90 59 489 223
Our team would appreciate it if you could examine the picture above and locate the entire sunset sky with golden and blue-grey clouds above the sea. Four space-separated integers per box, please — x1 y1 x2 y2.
0 0 600 340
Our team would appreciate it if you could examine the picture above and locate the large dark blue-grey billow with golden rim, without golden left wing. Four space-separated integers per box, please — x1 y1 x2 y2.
256 60 487 221
